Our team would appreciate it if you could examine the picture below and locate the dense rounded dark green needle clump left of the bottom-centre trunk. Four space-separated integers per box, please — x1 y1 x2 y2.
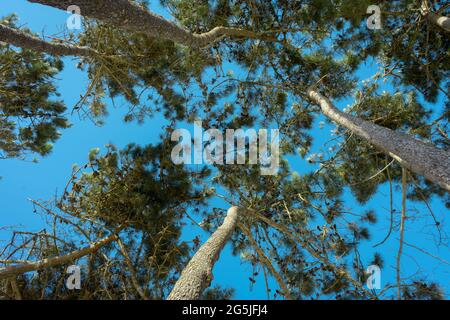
61 144 208 230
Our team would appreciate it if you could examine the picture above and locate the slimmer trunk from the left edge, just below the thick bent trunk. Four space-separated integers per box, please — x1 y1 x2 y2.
0 24 95 56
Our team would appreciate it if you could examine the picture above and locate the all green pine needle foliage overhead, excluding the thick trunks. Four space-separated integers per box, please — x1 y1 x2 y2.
0 0 450 299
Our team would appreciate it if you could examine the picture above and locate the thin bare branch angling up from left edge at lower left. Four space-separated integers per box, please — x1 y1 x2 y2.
0 234 117 280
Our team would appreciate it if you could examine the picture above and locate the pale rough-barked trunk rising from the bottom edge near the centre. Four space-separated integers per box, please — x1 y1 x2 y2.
167 207 240 300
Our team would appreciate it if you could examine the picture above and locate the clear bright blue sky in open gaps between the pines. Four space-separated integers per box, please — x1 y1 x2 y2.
0 0 450 299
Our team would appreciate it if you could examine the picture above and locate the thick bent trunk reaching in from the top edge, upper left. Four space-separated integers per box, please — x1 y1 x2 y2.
28 0 258 48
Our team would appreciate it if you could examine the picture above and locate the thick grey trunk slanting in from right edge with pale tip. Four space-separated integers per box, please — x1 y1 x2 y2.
308 88 450 191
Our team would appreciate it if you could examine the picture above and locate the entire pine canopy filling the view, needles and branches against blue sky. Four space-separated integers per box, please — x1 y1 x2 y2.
0 0 450 299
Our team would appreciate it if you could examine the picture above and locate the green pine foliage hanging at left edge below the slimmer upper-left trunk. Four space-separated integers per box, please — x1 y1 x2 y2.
0 16 69 158
